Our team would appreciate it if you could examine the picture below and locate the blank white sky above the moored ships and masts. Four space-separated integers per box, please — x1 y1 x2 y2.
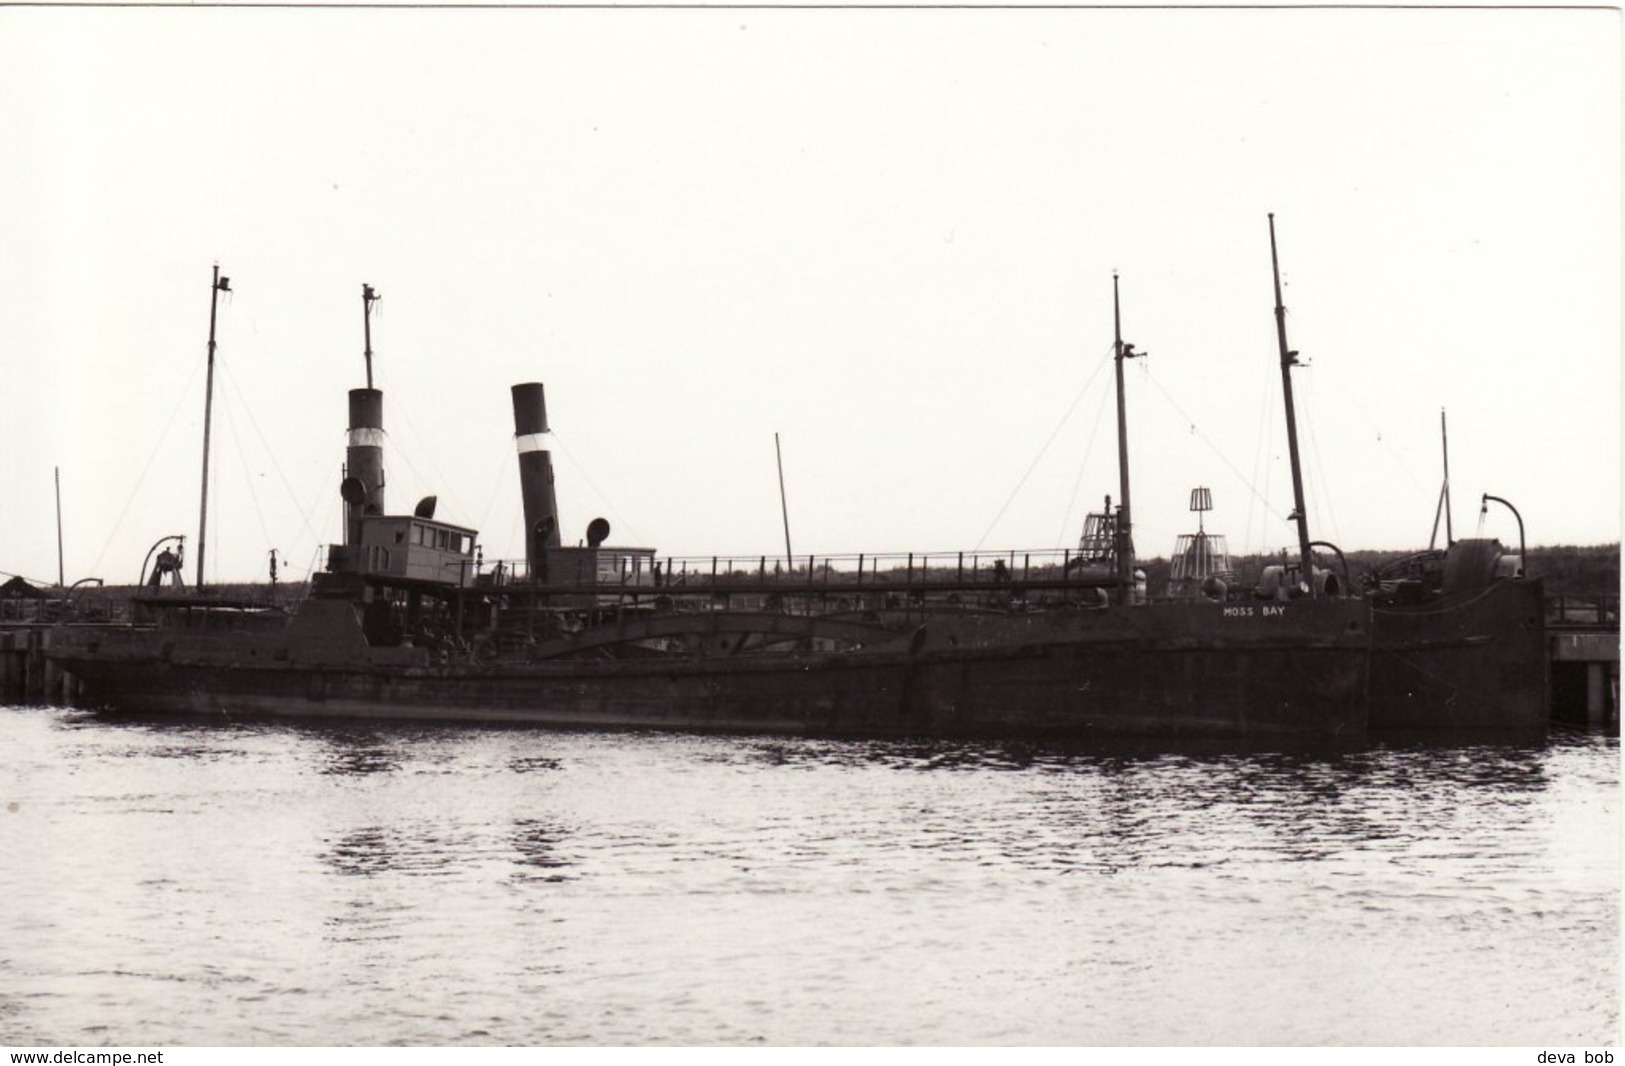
0 8 1622 583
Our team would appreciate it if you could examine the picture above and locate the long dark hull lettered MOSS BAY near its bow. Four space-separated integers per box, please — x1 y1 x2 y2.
57 601 1370 741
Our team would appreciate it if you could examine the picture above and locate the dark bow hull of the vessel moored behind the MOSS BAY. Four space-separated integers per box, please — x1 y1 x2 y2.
1370 580 1550 733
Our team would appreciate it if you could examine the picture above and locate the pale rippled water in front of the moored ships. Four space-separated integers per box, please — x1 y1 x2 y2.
0 709 1620 1047
